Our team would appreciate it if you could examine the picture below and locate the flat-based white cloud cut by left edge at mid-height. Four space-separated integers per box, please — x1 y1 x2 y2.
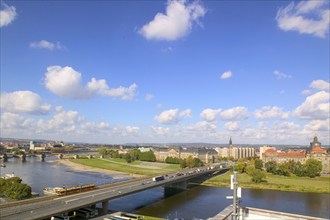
0 91 51 114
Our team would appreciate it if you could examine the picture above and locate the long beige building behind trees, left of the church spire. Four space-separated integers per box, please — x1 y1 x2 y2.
154 147 217 163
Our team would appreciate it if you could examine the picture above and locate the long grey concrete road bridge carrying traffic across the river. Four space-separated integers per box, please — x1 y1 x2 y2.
0 168 229 220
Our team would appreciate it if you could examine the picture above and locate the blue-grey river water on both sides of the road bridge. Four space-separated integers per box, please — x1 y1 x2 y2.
0 157 330 220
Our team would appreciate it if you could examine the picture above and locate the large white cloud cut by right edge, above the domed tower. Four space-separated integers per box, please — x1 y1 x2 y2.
294 91 330 120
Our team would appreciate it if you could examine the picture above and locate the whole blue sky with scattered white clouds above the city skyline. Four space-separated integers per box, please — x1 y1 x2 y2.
0 0 330 146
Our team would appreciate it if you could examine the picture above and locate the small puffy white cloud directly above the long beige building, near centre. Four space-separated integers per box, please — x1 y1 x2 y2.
155 109 191 124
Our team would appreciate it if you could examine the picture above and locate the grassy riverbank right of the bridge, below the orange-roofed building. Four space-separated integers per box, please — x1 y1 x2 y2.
203 172 330 193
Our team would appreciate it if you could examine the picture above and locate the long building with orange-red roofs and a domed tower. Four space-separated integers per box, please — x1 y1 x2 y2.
260 136 330 174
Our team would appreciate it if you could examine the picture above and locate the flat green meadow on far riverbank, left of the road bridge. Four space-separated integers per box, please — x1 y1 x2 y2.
70 158 180 176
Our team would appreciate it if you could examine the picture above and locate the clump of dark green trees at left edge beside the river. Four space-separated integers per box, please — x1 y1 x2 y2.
0 177 32 200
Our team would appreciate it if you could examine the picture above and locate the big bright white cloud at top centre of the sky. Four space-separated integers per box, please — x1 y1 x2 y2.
139 0 206 41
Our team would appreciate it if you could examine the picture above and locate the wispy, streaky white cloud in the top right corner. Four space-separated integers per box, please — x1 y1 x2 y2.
276 0 330 38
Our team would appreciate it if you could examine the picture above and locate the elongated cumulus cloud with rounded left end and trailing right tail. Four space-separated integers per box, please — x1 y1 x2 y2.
44 66 137 100
